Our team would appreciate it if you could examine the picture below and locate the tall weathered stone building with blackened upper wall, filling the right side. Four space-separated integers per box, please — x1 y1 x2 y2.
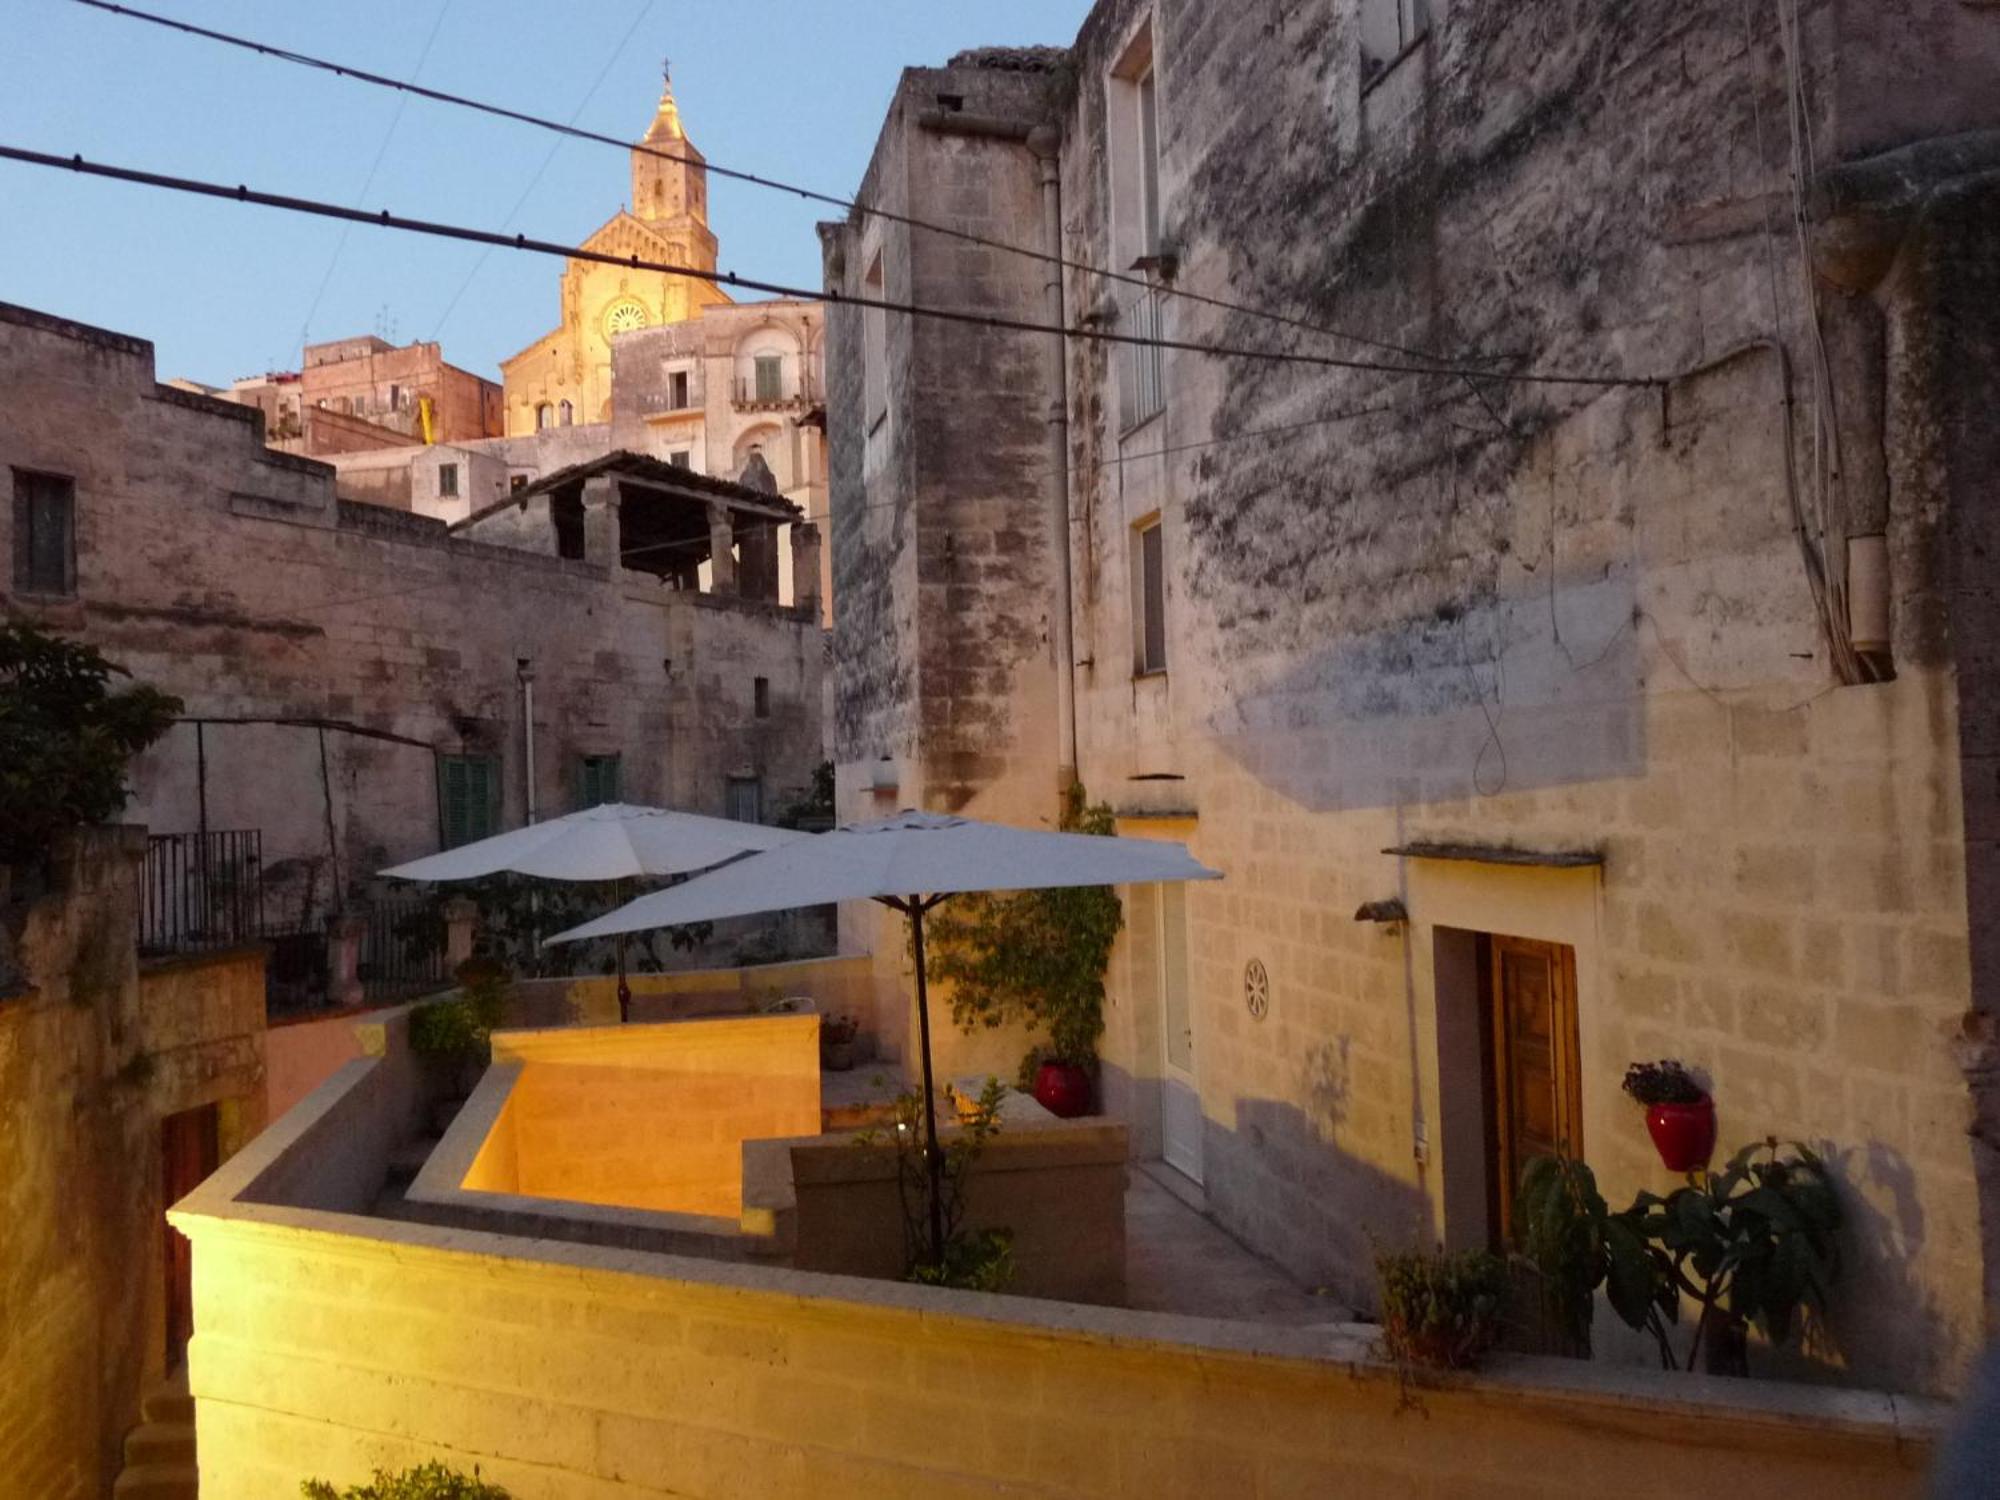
824 0 2000 1388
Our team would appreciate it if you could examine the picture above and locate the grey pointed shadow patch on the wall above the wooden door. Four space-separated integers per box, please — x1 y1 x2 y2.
1210 570 1646 812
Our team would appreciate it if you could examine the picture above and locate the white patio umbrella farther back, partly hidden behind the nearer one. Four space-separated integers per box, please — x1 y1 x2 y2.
380 802 806 1020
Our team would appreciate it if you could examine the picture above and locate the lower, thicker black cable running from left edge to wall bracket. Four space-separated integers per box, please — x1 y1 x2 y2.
0 141 1666 390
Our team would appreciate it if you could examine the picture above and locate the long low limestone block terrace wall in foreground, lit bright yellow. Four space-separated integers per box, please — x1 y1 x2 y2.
176 1060 1942 1500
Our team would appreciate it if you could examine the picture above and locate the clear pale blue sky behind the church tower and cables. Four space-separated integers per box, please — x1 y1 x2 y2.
0 0 1088 386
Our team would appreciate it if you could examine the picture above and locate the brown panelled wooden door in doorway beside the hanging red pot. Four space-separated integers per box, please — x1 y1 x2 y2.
1486 936 1584 1244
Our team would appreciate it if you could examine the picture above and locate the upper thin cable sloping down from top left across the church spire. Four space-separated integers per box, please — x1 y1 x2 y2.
76 0 1584 384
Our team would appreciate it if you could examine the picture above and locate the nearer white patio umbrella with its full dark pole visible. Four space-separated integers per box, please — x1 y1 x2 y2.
548 812 1222 1262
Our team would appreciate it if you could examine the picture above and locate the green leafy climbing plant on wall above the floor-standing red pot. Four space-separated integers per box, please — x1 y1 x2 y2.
926 786 1124 1066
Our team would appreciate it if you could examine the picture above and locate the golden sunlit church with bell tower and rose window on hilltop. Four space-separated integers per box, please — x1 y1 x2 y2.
500 72 730 436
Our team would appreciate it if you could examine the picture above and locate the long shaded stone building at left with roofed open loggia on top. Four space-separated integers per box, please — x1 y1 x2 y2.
0 306 822 936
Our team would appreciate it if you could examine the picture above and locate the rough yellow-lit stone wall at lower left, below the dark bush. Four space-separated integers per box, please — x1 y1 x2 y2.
0 828 264 1500
